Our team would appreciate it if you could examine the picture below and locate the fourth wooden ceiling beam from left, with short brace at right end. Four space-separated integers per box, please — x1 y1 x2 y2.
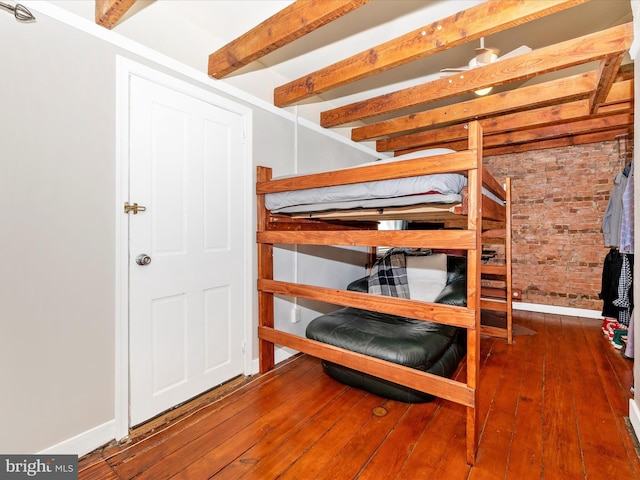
320 23 633 127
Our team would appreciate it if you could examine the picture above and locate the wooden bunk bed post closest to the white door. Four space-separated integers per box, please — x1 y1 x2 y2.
256 167 275 373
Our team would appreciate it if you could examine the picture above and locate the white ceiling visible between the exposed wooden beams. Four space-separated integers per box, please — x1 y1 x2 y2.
50 0 632 131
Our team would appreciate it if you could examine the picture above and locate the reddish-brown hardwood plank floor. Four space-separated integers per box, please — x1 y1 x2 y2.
79 312 640 480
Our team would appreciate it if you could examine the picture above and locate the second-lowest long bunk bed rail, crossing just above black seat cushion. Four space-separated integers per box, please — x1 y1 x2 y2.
258 279 475 328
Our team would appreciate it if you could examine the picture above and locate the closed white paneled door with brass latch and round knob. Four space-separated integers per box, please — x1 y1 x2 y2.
129 76 245 426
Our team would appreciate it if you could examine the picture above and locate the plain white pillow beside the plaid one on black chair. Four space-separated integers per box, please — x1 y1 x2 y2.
405 253 447 302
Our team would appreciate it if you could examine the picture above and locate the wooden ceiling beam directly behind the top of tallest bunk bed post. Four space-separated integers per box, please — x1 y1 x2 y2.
376 80 633 152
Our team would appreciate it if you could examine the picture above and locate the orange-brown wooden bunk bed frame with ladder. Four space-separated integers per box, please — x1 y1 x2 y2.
256 122 512 464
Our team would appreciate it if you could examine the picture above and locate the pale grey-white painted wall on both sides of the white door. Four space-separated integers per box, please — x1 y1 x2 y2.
0 4 370 454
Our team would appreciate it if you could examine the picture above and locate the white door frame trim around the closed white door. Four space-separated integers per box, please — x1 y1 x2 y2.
114 55 255 440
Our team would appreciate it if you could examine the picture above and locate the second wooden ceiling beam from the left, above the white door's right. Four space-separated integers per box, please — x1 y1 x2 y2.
208 0 369 78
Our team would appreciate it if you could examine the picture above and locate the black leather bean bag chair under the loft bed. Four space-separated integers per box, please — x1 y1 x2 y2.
306 256 467 403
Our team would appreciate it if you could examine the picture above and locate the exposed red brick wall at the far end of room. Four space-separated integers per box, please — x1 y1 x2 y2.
485 142 625 311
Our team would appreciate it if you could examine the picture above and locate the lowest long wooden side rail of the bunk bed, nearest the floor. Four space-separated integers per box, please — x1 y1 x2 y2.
258 327 475 408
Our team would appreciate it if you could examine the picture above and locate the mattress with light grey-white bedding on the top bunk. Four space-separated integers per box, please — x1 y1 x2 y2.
265 148 500 213
